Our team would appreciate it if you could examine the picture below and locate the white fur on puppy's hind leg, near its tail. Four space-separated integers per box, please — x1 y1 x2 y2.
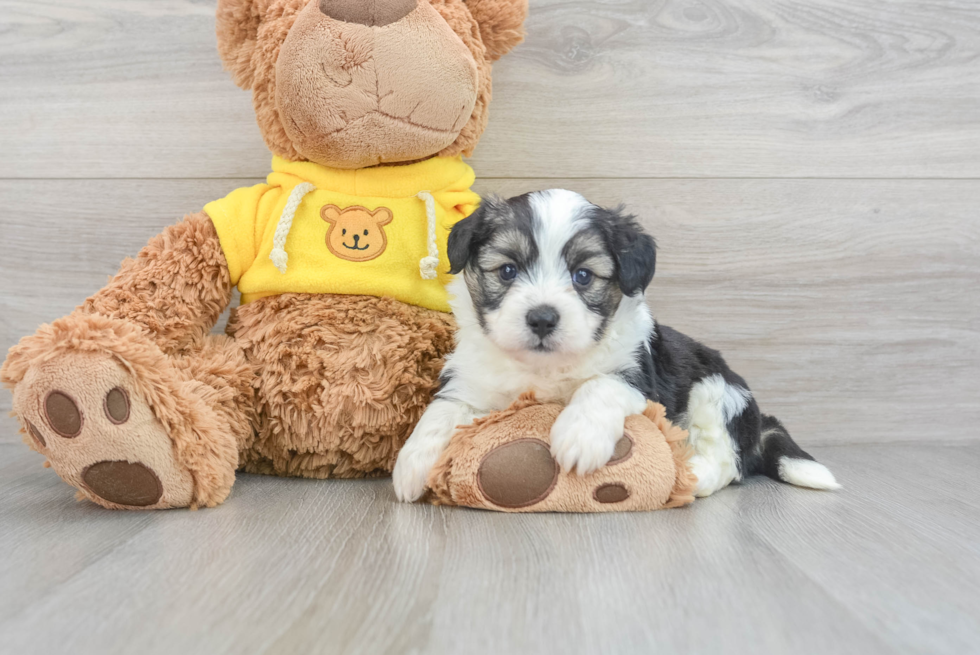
680 374 752 497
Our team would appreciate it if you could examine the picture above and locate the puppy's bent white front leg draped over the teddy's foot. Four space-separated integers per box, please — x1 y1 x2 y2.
551 375 646 475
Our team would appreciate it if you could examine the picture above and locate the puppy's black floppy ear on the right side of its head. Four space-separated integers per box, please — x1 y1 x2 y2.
597 207 657 296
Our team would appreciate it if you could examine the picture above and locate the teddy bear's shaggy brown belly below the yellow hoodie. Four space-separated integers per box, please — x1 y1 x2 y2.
228 294 455 478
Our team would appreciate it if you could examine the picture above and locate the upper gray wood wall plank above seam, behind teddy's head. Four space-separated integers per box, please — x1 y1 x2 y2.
0 0 980 178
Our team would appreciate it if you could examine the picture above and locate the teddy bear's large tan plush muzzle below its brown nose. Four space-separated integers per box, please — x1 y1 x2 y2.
276 2 477 168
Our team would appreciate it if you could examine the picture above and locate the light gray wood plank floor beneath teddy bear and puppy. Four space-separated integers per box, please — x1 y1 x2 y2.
0 442 980 655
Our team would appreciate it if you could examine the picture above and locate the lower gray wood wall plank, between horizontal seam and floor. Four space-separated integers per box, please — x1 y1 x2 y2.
0 179 980 445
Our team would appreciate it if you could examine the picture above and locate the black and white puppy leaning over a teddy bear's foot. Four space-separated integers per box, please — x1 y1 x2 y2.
393 190 839 501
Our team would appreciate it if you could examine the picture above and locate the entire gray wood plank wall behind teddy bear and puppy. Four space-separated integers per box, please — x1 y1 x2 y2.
0 0 980 444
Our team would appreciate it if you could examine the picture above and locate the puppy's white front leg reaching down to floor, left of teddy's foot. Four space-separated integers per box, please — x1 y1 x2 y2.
391 398 477 503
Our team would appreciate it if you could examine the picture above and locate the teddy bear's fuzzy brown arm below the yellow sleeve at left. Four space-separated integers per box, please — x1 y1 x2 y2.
76 212 232 353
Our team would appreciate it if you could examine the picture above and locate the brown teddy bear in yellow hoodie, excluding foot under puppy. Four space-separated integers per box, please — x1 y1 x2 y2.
0 0 527 509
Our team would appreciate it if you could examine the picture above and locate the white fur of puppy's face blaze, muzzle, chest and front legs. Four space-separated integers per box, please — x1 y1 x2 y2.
393 191 653 501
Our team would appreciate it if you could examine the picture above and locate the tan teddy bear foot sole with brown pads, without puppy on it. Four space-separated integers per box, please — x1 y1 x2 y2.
14 352 194 509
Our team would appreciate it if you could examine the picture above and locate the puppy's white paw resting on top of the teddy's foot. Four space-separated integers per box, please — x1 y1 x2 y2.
551 405 623 475
